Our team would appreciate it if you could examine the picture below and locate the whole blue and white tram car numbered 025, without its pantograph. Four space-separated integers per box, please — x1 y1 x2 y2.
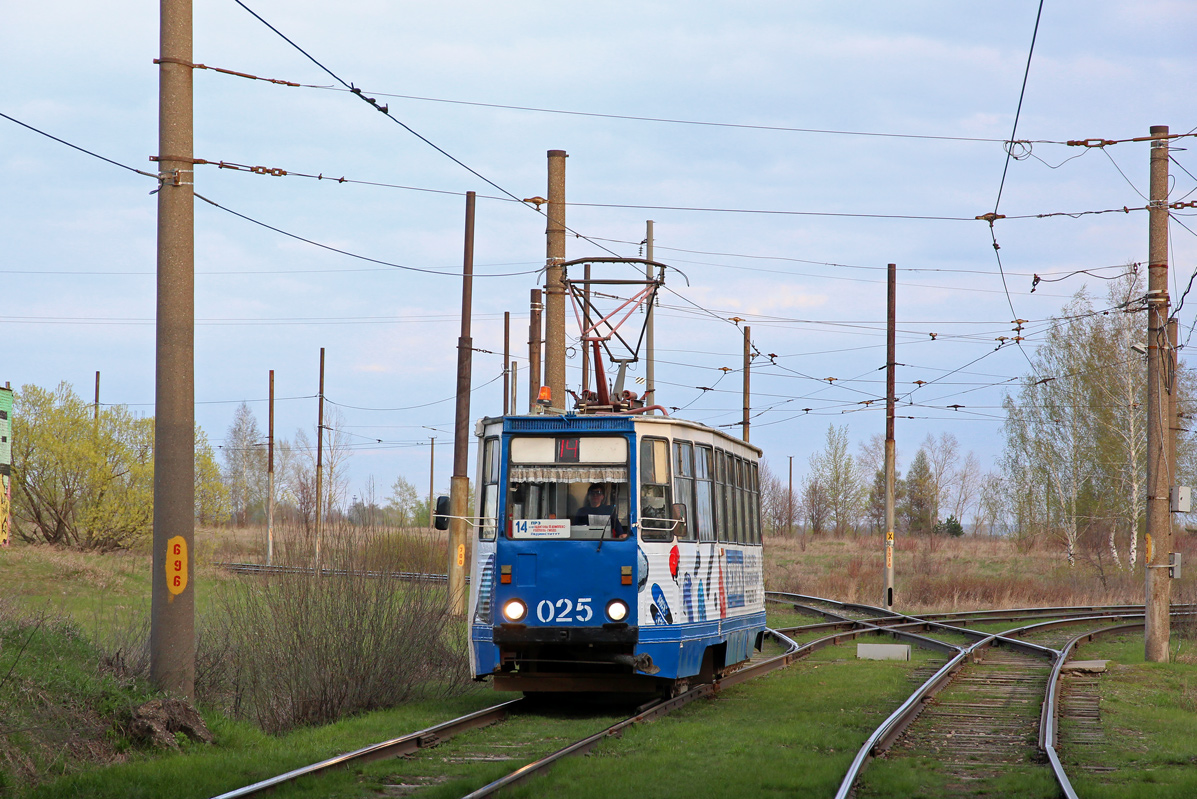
468 414 765 693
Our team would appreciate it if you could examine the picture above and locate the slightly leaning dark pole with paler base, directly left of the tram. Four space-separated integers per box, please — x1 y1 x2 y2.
449 191 474 616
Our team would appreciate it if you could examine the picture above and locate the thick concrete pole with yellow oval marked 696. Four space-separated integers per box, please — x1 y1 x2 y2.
150 0 195 699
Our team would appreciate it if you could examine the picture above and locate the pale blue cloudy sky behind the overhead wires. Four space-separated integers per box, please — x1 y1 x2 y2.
0 0 1197 504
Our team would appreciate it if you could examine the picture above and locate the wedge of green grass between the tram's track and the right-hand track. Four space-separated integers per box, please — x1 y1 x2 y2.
416 646 917 799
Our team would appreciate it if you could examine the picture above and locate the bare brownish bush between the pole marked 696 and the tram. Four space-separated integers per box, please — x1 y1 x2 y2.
205 530 468 732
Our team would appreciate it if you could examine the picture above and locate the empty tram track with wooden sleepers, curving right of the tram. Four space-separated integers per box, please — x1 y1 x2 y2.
767 592 1195 799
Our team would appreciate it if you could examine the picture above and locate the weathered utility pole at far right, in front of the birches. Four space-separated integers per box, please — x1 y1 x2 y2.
1143 124 1175 663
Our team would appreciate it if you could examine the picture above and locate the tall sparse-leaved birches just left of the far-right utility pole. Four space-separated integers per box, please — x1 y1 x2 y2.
1003 281 1168 565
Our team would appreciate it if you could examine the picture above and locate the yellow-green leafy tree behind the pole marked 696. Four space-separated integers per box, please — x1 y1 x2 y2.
12 383 220 549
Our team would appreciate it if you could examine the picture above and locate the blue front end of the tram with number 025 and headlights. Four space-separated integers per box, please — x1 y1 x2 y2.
469 416 657 691
